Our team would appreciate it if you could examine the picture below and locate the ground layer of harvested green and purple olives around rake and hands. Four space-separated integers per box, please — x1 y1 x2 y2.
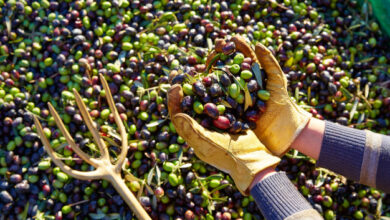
0 0 390 220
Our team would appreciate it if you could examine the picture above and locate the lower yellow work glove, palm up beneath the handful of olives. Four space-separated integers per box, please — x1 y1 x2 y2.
168 85 280 195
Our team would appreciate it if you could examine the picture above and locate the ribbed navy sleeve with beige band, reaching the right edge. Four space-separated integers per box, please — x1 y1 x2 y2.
317 122 390 192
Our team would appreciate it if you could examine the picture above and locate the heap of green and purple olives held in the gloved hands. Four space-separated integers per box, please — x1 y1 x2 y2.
172 38 270 134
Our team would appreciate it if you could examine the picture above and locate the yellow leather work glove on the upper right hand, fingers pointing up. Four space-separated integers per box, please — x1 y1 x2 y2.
254 43 311 156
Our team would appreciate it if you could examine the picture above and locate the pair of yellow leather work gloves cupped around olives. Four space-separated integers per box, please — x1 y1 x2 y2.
168 36 311 195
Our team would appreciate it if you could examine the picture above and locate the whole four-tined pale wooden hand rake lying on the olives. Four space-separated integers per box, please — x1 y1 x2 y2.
34 74 151 219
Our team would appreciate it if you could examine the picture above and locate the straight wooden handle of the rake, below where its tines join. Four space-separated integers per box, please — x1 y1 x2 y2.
108 174 151 220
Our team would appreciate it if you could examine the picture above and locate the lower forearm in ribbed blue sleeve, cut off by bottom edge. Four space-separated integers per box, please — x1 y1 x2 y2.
250 170 322 219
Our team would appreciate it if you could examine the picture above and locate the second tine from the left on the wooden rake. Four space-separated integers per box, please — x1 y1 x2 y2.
47 103 97 168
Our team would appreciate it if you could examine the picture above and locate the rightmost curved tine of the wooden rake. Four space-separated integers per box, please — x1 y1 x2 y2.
100 74 128 172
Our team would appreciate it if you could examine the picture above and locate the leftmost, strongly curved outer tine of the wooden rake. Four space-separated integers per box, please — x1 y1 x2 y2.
34 116 103 180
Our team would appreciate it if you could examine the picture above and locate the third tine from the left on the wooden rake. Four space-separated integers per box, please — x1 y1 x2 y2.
73 89 109 159
